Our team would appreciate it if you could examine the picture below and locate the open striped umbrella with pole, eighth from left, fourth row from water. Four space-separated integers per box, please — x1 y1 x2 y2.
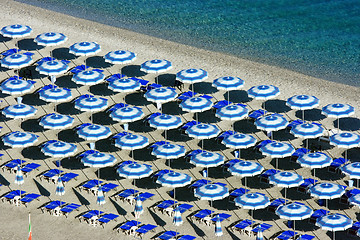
269 172 304 200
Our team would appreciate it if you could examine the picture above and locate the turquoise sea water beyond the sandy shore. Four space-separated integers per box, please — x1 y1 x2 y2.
21 0 360 86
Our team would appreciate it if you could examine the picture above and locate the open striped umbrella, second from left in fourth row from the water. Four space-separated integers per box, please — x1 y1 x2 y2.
40 113 74 129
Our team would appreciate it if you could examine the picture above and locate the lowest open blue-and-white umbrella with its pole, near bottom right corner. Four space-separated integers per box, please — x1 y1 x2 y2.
316 213 353 239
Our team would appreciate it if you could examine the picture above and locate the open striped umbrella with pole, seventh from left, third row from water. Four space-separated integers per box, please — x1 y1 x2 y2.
222 133 257 158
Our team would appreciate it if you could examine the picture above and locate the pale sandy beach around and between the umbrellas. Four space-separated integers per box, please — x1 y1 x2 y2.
0 0 360 240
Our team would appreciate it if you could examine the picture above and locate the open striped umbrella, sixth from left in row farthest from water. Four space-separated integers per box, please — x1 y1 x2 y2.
194 184 229 201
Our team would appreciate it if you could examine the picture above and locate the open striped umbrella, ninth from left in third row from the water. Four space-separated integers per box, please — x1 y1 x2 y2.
297 152 332 168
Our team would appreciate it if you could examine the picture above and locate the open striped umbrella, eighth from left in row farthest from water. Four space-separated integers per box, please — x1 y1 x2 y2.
275 203 313 220
